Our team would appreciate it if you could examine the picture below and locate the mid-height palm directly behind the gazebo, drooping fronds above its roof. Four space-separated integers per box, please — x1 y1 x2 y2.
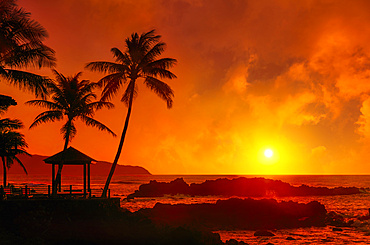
26 70 116 194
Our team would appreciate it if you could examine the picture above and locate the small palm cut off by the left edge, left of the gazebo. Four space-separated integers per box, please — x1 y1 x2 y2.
0 120 30 187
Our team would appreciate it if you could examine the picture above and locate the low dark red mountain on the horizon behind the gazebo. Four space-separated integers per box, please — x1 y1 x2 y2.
0 155 150 176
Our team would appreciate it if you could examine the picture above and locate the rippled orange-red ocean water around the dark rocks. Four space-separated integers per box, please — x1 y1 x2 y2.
8 175 370 244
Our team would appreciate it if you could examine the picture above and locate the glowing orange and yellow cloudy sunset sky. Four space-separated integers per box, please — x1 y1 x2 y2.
0 0 370 175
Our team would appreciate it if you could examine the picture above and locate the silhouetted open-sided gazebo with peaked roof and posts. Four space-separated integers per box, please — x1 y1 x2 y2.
44 147 96 196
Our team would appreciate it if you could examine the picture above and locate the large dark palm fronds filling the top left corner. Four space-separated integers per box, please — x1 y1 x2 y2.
0 0 55 96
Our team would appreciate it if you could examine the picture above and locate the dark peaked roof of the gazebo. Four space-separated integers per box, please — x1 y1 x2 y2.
44 146 96 165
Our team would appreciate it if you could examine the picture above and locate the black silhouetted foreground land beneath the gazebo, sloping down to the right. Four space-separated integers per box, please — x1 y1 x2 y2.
0 199 222 245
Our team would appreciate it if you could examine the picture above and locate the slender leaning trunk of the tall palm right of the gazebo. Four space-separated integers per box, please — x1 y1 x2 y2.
101 82 135 197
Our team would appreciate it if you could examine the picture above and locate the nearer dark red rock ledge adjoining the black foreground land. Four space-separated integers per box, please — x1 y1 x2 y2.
136 198 326 230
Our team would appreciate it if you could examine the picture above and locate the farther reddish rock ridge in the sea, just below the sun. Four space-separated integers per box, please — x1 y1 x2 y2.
129 177 360 198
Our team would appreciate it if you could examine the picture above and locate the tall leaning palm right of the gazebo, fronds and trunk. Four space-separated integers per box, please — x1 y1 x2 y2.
86 30 177 197
